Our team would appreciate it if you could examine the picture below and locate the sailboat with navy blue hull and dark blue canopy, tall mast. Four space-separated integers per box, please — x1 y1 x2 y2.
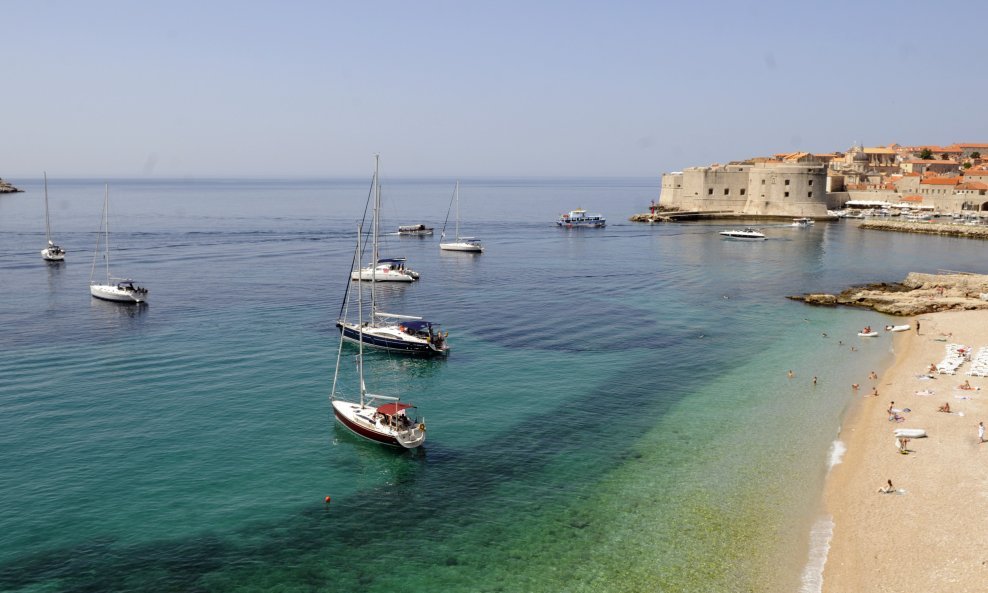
336 155 449 356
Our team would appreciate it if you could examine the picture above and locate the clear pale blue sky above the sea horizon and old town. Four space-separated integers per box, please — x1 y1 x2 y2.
0 0 988 179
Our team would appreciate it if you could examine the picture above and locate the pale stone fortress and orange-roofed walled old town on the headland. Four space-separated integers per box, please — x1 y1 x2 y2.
659 143 988 218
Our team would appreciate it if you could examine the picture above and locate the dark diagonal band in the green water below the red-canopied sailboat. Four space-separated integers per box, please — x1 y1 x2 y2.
0 324 724 592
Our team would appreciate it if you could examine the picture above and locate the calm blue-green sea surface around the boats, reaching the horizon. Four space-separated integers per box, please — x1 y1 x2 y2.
0 177 988 593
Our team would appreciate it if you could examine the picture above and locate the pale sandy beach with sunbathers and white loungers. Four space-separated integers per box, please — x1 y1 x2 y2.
822 311 988 593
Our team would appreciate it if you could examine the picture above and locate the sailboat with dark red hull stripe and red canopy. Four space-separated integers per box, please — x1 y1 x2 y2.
330 226 425 449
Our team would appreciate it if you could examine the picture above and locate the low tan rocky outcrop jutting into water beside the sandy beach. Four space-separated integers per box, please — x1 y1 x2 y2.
788 272 988 316
